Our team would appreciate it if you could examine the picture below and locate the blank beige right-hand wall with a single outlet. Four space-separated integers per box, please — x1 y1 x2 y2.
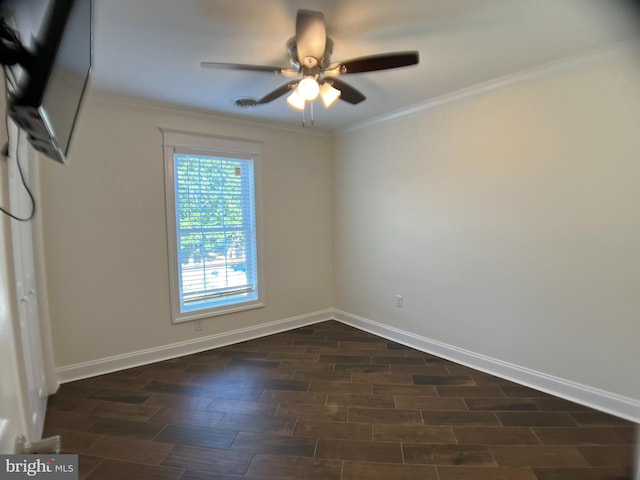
333 47 640 408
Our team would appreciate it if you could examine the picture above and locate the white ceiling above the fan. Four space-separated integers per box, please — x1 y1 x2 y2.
91 0 638 130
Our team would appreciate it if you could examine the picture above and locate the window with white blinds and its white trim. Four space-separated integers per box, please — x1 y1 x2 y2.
163 130 264 323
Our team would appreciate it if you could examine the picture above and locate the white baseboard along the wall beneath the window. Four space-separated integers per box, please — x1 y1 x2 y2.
56 309 333 383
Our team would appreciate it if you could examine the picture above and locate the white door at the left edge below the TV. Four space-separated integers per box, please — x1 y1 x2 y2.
0 84 49 453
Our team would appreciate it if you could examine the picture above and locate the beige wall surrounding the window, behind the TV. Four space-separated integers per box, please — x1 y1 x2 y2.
41 96 332 369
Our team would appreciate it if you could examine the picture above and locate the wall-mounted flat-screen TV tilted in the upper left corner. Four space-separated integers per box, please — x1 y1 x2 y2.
2 0 93 163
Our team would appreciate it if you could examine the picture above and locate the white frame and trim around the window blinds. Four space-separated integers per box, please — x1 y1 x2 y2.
160 128 265 324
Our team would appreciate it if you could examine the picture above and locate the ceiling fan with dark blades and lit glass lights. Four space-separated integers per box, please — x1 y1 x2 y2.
201 9 419 117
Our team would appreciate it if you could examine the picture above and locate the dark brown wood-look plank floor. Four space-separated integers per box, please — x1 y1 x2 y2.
45 321 635 480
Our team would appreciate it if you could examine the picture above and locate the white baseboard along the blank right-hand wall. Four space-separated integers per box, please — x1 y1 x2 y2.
333 310 640 423
